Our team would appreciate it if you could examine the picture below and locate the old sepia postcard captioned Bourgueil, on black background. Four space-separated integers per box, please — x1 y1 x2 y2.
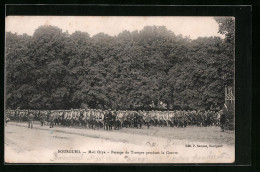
4 15 236 164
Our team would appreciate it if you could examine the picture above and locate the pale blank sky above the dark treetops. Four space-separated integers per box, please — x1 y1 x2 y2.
6 16 224 39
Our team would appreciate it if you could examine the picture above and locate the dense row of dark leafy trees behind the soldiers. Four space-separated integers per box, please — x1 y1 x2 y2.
5 18 234 109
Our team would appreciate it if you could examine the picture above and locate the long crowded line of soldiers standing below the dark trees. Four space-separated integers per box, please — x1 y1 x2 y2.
6 109 222 130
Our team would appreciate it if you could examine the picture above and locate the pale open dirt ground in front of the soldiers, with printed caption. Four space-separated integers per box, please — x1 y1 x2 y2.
5 123 234 163
